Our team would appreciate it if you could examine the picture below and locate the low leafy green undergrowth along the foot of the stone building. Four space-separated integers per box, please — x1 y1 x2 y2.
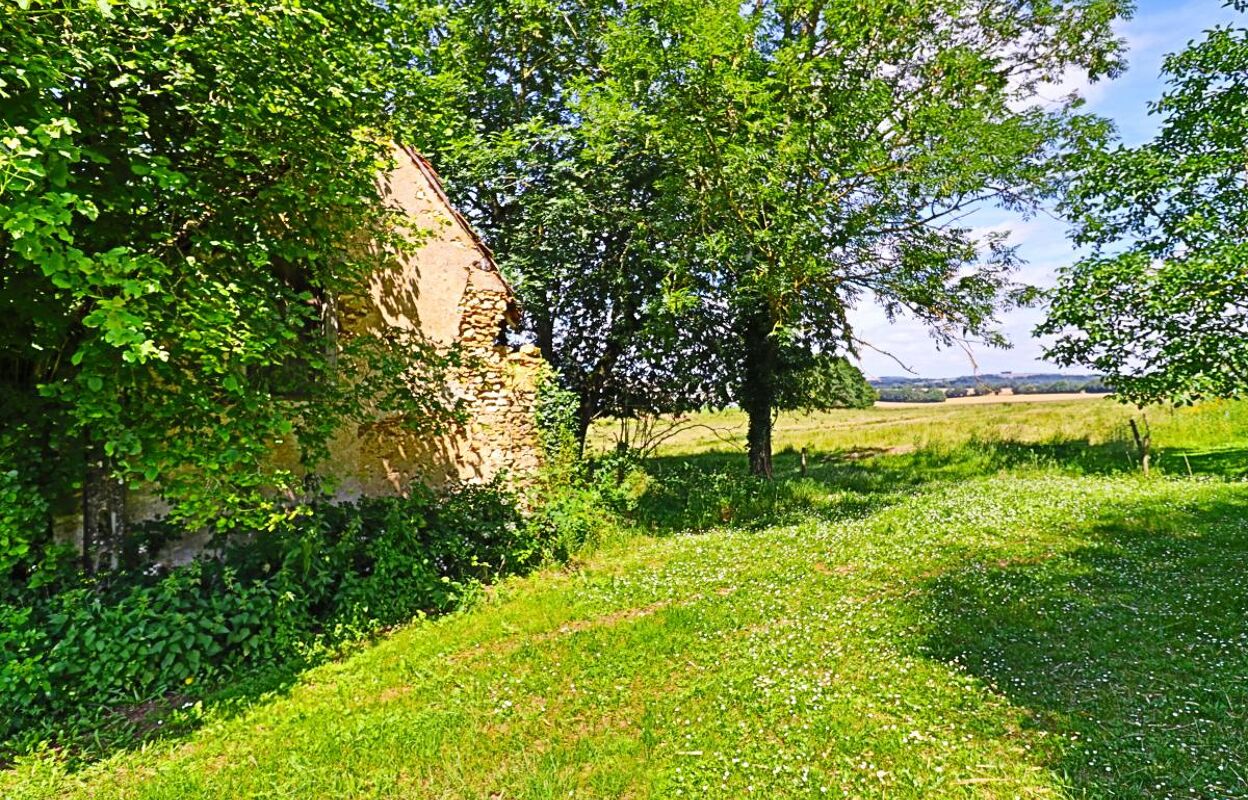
0 487 539 754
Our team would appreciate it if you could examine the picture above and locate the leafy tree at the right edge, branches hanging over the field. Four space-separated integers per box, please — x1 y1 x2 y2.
1037 4 1248 411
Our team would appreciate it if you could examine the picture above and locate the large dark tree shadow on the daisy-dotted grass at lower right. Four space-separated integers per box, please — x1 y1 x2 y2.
921 494 1248 799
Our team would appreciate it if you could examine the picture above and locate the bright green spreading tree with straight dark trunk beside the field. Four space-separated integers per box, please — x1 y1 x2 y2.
582 0 1124 476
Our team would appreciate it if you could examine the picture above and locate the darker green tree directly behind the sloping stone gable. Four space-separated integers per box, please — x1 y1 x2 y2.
429 0 665 442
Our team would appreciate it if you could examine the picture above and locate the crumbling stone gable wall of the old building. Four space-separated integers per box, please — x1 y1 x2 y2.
322 147 545 497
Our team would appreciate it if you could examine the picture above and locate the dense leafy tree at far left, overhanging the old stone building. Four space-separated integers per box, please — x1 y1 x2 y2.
0 0 449 568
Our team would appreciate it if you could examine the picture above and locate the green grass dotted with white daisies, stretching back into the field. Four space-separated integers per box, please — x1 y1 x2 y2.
7 399 1248 799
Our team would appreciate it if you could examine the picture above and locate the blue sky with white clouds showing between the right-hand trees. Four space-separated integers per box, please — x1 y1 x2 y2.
851 0 1244 378
